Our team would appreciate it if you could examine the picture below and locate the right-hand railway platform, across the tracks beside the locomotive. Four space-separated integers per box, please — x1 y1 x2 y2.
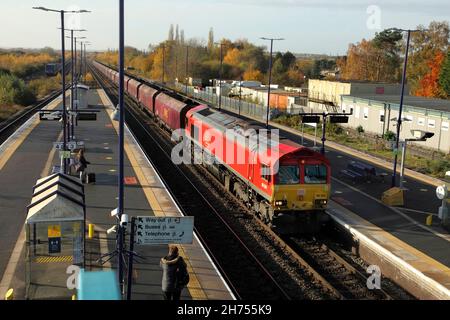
214 105 450 300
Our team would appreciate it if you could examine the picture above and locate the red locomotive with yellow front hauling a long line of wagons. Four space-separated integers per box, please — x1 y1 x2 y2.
93 61 331 234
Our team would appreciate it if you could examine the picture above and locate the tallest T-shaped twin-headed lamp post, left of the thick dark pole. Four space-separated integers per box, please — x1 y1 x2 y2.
33 7 90 174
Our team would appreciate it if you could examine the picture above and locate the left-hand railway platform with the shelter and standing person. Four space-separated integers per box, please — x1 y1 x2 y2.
0 90 234 300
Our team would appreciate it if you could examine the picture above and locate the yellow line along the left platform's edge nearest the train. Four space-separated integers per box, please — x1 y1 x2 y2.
98 89 207 300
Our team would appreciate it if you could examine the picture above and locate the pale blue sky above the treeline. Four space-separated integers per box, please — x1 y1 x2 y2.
0 0 450 54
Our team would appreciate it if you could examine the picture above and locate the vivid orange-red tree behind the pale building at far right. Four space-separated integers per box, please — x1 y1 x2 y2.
415 51 445 98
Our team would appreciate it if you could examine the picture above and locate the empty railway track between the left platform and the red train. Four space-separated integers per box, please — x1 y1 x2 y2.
93 64 296 300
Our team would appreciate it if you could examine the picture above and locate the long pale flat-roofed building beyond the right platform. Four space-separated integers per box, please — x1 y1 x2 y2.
304 80 450 153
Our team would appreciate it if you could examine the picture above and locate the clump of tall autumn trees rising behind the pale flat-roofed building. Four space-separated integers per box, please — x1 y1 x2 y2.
337 21 450 97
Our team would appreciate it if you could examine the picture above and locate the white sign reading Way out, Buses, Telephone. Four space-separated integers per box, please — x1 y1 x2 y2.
135 217 194 245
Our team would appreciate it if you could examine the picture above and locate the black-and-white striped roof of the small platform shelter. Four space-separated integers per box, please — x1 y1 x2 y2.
26 173 86 224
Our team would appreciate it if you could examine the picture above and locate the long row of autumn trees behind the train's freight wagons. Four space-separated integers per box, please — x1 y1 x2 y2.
97 25 324 86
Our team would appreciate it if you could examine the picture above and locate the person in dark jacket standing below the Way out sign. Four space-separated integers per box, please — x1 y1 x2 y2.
159 245 186 301
